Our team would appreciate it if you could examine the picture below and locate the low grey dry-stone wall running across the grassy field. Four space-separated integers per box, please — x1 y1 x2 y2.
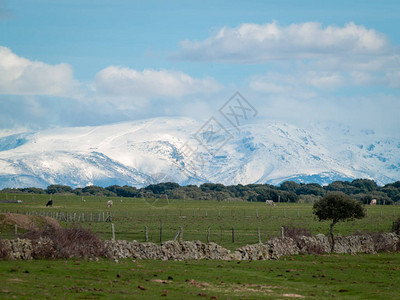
1 233 400 260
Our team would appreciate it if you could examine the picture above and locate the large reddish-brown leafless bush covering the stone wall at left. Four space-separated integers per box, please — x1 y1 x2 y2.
25 226 105 258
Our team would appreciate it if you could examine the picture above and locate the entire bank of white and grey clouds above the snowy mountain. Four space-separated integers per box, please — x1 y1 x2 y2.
0 22 400 131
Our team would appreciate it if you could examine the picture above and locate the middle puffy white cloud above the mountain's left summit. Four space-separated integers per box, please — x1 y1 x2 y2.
95 66 221 100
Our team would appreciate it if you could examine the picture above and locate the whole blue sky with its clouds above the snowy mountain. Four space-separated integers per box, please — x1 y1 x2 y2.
0 0 400 137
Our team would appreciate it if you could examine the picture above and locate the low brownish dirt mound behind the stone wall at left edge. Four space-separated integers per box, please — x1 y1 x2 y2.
0 213 61 230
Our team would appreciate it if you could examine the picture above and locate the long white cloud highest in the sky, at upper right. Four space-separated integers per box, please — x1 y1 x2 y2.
173 22 390 63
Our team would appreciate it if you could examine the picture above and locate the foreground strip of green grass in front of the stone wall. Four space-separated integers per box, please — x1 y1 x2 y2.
0 254 400 299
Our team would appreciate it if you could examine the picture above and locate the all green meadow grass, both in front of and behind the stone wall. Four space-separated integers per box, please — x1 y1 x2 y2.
0 194 400 299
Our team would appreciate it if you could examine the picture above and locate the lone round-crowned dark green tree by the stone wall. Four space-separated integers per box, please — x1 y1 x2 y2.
313 192 365 252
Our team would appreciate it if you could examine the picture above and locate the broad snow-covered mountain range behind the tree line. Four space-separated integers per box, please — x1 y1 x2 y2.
0 118 400 188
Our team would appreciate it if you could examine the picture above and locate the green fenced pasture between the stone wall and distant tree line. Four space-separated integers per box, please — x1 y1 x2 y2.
0 193 400 249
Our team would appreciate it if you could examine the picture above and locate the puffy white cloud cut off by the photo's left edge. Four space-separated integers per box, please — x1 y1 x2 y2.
0 47 79 96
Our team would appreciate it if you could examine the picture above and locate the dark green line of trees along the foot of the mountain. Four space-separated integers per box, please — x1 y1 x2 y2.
2 179 400 205
